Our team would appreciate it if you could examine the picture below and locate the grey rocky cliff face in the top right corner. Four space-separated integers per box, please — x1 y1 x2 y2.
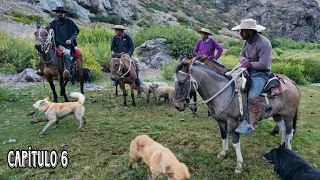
229 0 320 41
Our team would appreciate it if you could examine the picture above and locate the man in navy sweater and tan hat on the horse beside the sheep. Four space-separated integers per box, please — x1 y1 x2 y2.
111 25 142 85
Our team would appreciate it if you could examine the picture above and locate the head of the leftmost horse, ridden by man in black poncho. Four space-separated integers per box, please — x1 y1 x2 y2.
34 23 53 54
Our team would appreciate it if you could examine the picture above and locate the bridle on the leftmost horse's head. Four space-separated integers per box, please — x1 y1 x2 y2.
38 27 57 64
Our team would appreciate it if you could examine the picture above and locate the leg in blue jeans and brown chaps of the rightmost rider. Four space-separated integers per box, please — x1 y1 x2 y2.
235 72 269 134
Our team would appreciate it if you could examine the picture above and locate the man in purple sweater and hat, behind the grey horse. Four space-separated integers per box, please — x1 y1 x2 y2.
193 28 223 61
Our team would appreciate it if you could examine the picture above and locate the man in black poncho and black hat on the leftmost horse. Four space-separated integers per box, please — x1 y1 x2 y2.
48 7 79 78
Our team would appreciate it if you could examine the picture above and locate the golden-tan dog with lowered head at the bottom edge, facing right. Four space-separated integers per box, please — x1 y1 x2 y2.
128 135 190 180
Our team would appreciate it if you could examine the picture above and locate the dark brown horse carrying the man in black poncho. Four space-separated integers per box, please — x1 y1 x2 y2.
34 24 84 102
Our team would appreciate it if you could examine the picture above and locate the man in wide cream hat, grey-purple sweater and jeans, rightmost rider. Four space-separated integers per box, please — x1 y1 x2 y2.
231 19 272 134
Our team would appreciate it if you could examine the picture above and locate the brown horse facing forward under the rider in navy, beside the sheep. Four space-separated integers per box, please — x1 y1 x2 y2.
110 53 137 107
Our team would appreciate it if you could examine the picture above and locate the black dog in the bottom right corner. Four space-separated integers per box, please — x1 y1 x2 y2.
262 143 320 180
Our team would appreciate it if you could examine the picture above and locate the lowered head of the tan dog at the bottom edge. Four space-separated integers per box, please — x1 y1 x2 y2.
166 163 190 180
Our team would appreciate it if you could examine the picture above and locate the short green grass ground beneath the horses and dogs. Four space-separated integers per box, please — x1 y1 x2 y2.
0 74 320 180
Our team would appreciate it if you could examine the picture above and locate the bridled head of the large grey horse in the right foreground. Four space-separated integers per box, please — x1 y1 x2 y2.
173 58 196 111
